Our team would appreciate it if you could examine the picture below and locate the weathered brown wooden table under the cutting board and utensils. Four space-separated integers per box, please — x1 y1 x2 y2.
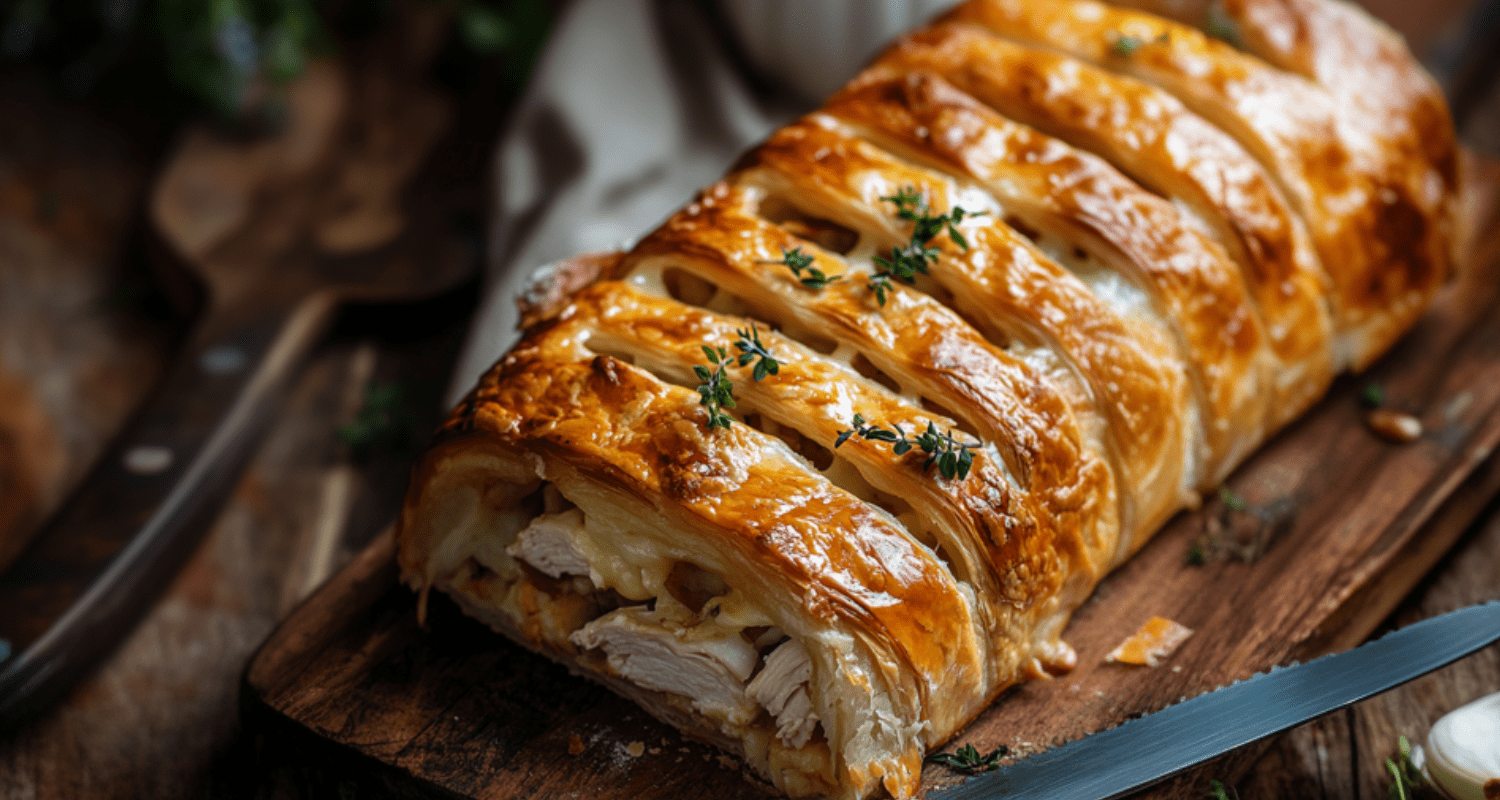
0 0 1500 800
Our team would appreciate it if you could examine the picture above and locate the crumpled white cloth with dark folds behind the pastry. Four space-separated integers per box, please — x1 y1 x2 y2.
449 0 954 402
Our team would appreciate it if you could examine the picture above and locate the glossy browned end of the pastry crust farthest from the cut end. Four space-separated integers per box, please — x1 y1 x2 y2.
950 0 1457 368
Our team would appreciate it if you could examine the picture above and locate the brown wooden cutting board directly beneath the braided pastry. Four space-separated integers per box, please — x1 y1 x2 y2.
245 157 1500 800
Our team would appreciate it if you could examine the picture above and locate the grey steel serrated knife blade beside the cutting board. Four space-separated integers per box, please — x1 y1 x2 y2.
933 602 1500 800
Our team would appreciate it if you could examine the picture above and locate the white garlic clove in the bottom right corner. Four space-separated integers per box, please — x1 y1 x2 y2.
1421 692 1500 800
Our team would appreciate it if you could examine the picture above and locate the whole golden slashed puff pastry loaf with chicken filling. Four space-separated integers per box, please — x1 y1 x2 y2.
398 0 1457 797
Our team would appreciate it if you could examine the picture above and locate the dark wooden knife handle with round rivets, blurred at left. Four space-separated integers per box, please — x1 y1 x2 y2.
0 291 336 729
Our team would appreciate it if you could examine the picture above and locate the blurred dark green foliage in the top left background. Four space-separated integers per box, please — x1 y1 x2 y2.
0 0 552 122
